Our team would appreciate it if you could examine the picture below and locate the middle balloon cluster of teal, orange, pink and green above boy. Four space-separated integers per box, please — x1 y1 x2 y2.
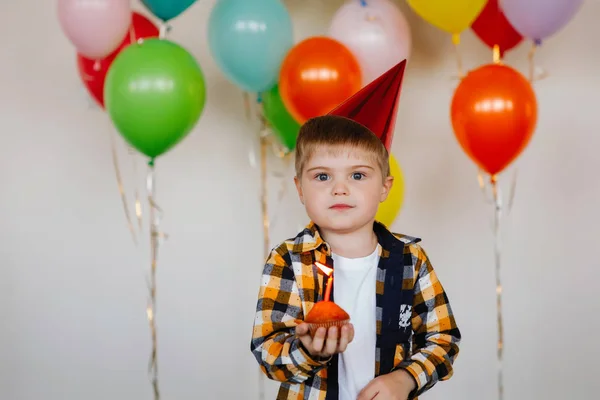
208 0 411 150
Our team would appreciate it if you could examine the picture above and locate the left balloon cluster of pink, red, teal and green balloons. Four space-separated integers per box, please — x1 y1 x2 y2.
58 0 206 161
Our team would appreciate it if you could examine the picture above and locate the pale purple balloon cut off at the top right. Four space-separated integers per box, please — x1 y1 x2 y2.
500 0 583 41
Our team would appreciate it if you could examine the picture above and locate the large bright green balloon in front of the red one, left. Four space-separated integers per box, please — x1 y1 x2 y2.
104 39 206 160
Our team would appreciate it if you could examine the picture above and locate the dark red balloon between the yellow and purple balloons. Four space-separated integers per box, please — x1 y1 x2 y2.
471 0 523 57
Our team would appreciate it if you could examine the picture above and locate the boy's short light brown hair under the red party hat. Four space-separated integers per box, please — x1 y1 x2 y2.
296 115 390 179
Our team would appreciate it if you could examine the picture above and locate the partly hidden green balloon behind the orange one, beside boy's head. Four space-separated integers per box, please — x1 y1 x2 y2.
263 85 300 151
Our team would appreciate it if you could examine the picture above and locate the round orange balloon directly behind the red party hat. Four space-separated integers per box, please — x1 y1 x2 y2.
279 37 362 123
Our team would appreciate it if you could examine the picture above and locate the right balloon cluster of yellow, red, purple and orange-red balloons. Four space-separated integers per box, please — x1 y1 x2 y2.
408 0 583 181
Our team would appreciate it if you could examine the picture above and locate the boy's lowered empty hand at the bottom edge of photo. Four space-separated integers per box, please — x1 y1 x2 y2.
357 370 416 400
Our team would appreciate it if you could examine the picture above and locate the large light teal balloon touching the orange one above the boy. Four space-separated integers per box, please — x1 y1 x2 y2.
208 0 294 93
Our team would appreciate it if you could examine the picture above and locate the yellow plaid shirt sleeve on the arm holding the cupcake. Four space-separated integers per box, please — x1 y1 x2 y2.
250 245 327 383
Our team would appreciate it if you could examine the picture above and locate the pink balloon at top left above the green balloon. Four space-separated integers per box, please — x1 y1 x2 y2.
58 0 132 60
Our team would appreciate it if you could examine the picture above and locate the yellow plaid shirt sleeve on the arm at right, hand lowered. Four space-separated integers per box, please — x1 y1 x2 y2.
397 246 461 399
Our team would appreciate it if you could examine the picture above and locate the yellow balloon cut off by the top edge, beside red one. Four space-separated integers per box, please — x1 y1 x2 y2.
408 0 488 35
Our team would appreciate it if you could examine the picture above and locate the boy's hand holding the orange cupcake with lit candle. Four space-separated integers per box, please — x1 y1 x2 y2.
296 323 354 358
